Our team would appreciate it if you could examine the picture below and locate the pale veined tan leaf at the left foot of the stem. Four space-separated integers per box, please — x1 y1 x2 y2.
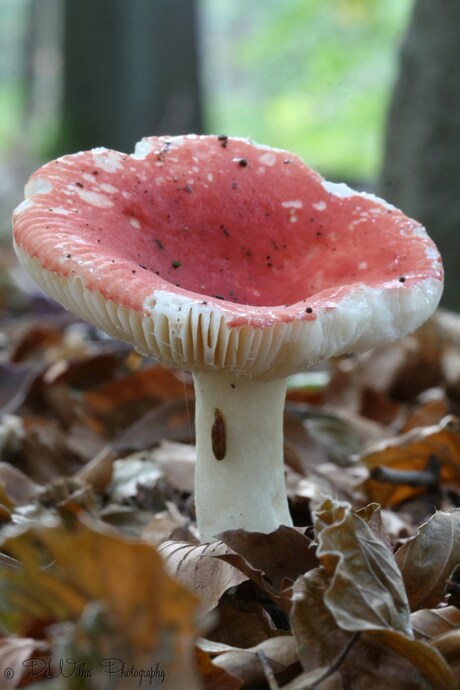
158 541 247 612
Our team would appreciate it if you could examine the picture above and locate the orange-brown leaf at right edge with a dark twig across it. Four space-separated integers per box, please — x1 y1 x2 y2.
361 417 460 507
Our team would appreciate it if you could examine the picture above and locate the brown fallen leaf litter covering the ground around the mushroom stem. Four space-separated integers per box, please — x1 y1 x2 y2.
0 242 460 690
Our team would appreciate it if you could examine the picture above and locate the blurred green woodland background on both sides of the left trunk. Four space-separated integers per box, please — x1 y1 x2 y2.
0 0 411 180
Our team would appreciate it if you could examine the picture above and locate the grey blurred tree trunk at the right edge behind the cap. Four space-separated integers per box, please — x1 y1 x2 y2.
381 0 460 310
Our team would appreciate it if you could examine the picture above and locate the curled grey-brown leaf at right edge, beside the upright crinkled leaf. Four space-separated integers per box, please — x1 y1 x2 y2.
396 509 460 610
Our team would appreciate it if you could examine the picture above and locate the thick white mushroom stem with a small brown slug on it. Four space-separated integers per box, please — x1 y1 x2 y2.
194 372 292 541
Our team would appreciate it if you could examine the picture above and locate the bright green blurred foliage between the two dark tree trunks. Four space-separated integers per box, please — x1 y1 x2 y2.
203 0 412 179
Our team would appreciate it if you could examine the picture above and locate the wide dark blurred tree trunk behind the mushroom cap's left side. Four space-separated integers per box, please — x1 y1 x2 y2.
59 0 202 152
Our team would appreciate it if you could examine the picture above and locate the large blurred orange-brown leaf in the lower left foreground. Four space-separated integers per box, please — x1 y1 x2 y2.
0 523 203 690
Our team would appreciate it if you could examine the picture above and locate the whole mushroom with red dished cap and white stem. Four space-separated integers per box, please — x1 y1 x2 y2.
14 135 442 540
